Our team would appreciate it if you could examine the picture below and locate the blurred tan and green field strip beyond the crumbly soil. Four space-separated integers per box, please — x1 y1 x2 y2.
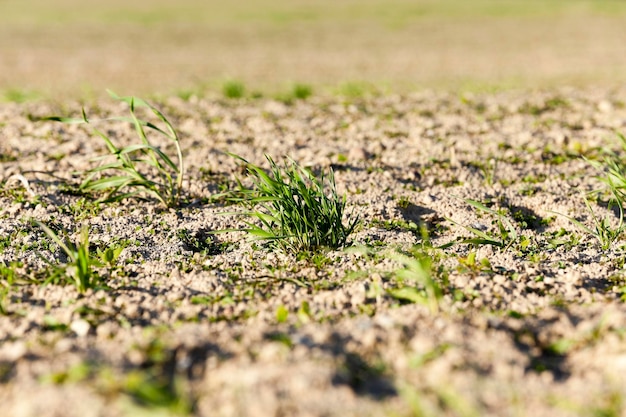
0 0 626 100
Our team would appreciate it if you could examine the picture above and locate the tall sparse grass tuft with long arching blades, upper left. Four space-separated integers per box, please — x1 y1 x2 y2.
47 91 185 207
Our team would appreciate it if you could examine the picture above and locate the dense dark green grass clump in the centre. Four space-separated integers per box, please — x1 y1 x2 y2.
233 155 359 253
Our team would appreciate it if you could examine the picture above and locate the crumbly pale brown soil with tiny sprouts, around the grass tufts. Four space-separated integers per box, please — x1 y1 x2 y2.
0 89 626 417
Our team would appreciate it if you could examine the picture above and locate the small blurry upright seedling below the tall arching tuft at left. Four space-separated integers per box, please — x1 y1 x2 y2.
35 222 100 293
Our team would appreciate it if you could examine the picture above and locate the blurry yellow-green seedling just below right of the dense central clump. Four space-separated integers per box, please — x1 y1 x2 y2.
388 253 443 313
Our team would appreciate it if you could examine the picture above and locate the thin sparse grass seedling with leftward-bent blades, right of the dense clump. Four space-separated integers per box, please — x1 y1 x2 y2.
442 199 518 250
